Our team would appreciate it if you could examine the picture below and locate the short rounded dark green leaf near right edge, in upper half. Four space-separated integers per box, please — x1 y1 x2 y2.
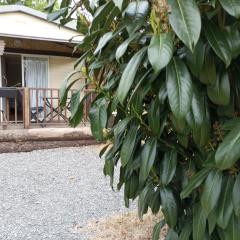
207 72 230 106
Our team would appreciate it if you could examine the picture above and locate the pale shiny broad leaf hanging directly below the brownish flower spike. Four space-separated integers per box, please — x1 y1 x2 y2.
148 33 173 72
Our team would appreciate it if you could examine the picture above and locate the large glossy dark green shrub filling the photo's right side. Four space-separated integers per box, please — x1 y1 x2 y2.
52 0 240 240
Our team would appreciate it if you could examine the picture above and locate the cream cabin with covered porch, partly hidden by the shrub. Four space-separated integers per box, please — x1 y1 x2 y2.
0 5 88 129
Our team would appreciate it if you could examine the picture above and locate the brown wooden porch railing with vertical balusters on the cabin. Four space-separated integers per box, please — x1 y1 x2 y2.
0 88 94 128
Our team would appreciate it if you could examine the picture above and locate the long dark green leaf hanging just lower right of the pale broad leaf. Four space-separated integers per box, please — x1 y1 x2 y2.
166 58 193 119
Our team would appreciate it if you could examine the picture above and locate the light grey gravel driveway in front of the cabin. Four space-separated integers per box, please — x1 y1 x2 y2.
0 146 131 240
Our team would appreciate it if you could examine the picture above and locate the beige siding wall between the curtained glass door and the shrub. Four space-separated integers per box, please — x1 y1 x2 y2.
49 56 84 89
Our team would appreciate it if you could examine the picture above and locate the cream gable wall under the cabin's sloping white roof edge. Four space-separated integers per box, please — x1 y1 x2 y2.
0 12 82 42
